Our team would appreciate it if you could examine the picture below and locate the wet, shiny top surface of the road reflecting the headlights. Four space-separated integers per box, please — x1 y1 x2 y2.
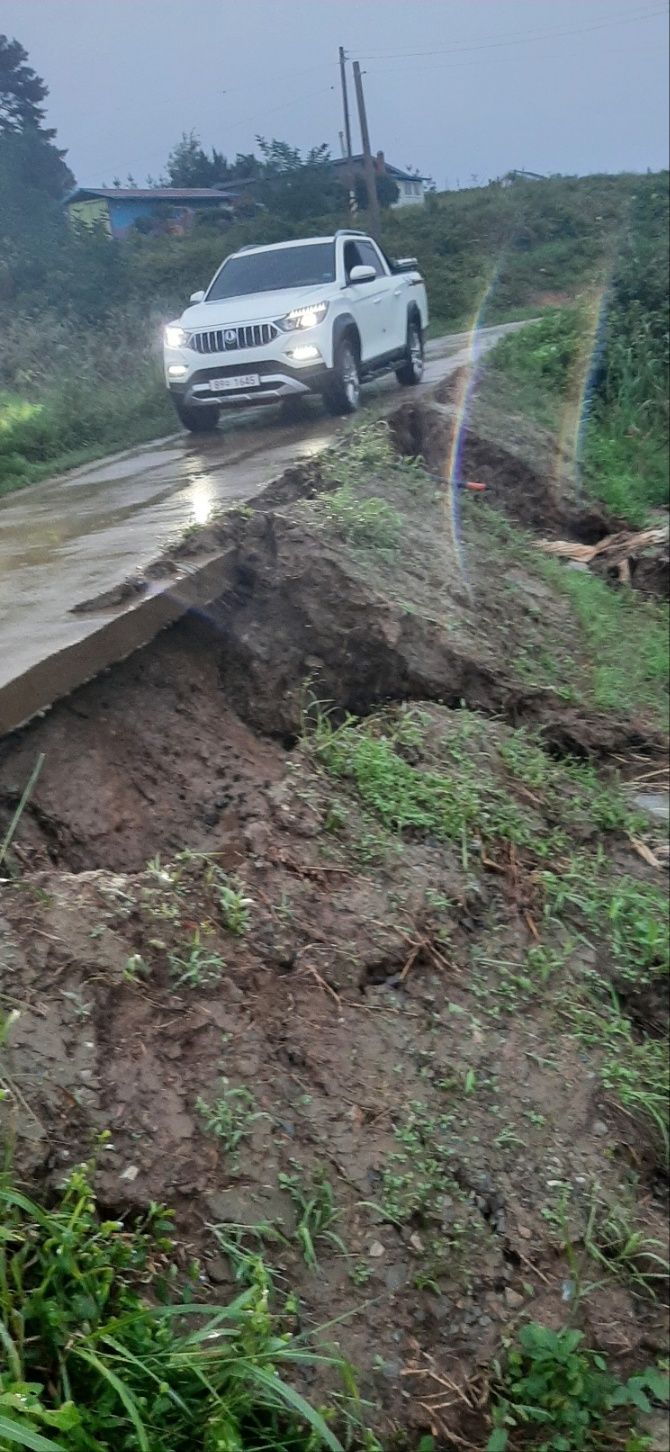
0 324 519 690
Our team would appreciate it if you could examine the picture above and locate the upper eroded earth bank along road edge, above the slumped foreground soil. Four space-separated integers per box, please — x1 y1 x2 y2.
0 467 663 871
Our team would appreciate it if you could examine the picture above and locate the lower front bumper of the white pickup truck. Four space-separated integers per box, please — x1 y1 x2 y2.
167 354 328 408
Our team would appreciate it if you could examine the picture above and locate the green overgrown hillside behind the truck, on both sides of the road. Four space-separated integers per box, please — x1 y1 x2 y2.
0 176 654 494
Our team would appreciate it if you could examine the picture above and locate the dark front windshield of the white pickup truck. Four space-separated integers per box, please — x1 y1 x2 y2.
206 242 334 302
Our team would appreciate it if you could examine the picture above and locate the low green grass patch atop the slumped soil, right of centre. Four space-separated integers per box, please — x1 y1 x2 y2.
305 707 644 860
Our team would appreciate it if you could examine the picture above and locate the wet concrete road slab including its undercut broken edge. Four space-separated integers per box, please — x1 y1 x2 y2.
0 324 520 735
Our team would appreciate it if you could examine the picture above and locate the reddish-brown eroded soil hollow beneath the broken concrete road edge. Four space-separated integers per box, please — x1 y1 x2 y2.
0 619 283 871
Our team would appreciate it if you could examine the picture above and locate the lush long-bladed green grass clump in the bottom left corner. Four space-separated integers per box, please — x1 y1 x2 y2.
0 1169 347 1452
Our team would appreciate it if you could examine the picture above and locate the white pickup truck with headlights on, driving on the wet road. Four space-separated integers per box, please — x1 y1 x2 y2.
163 231 427 433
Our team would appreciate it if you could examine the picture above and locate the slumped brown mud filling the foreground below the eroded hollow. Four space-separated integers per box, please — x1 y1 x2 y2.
1 699 664 1448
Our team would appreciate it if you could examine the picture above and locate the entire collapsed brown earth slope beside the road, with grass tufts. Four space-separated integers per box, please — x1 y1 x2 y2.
0 383 667 1449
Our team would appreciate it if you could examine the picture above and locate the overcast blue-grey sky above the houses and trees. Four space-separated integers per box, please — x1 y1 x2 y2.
0 0 669 187
